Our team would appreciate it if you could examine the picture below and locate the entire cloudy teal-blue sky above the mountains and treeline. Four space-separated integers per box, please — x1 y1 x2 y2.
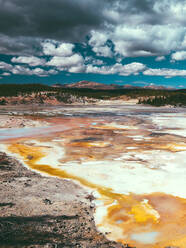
0 0 186 88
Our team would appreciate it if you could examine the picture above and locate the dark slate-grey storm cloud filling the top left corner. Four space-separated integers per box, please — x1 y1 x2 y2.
0 0 112 41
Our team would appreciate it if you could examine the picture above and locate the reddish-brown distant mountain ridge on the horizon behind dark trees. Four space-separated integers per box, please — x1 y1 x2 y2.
52 80 172 90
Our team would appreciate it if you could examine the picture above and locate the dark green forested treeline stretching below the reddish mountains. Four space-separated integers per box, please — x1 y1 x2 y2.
0 84 186 106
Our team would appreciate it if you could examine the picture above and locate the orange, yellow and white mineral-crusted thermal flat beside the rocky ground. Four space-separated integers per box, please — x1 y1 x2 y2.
0 108 186 248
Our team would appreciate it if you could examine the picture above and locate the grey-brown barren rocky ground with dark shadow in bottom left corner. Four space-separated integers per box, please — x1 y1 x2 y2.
0 153 127 248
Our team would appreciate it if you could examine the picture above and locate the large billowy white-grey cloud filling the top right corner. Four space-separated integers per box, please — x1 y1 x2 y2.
106 0 186 57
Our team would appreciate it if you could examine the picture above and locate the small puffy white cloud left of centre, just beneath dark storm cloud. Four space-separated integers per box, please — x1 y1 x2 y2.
42 40 75 57
